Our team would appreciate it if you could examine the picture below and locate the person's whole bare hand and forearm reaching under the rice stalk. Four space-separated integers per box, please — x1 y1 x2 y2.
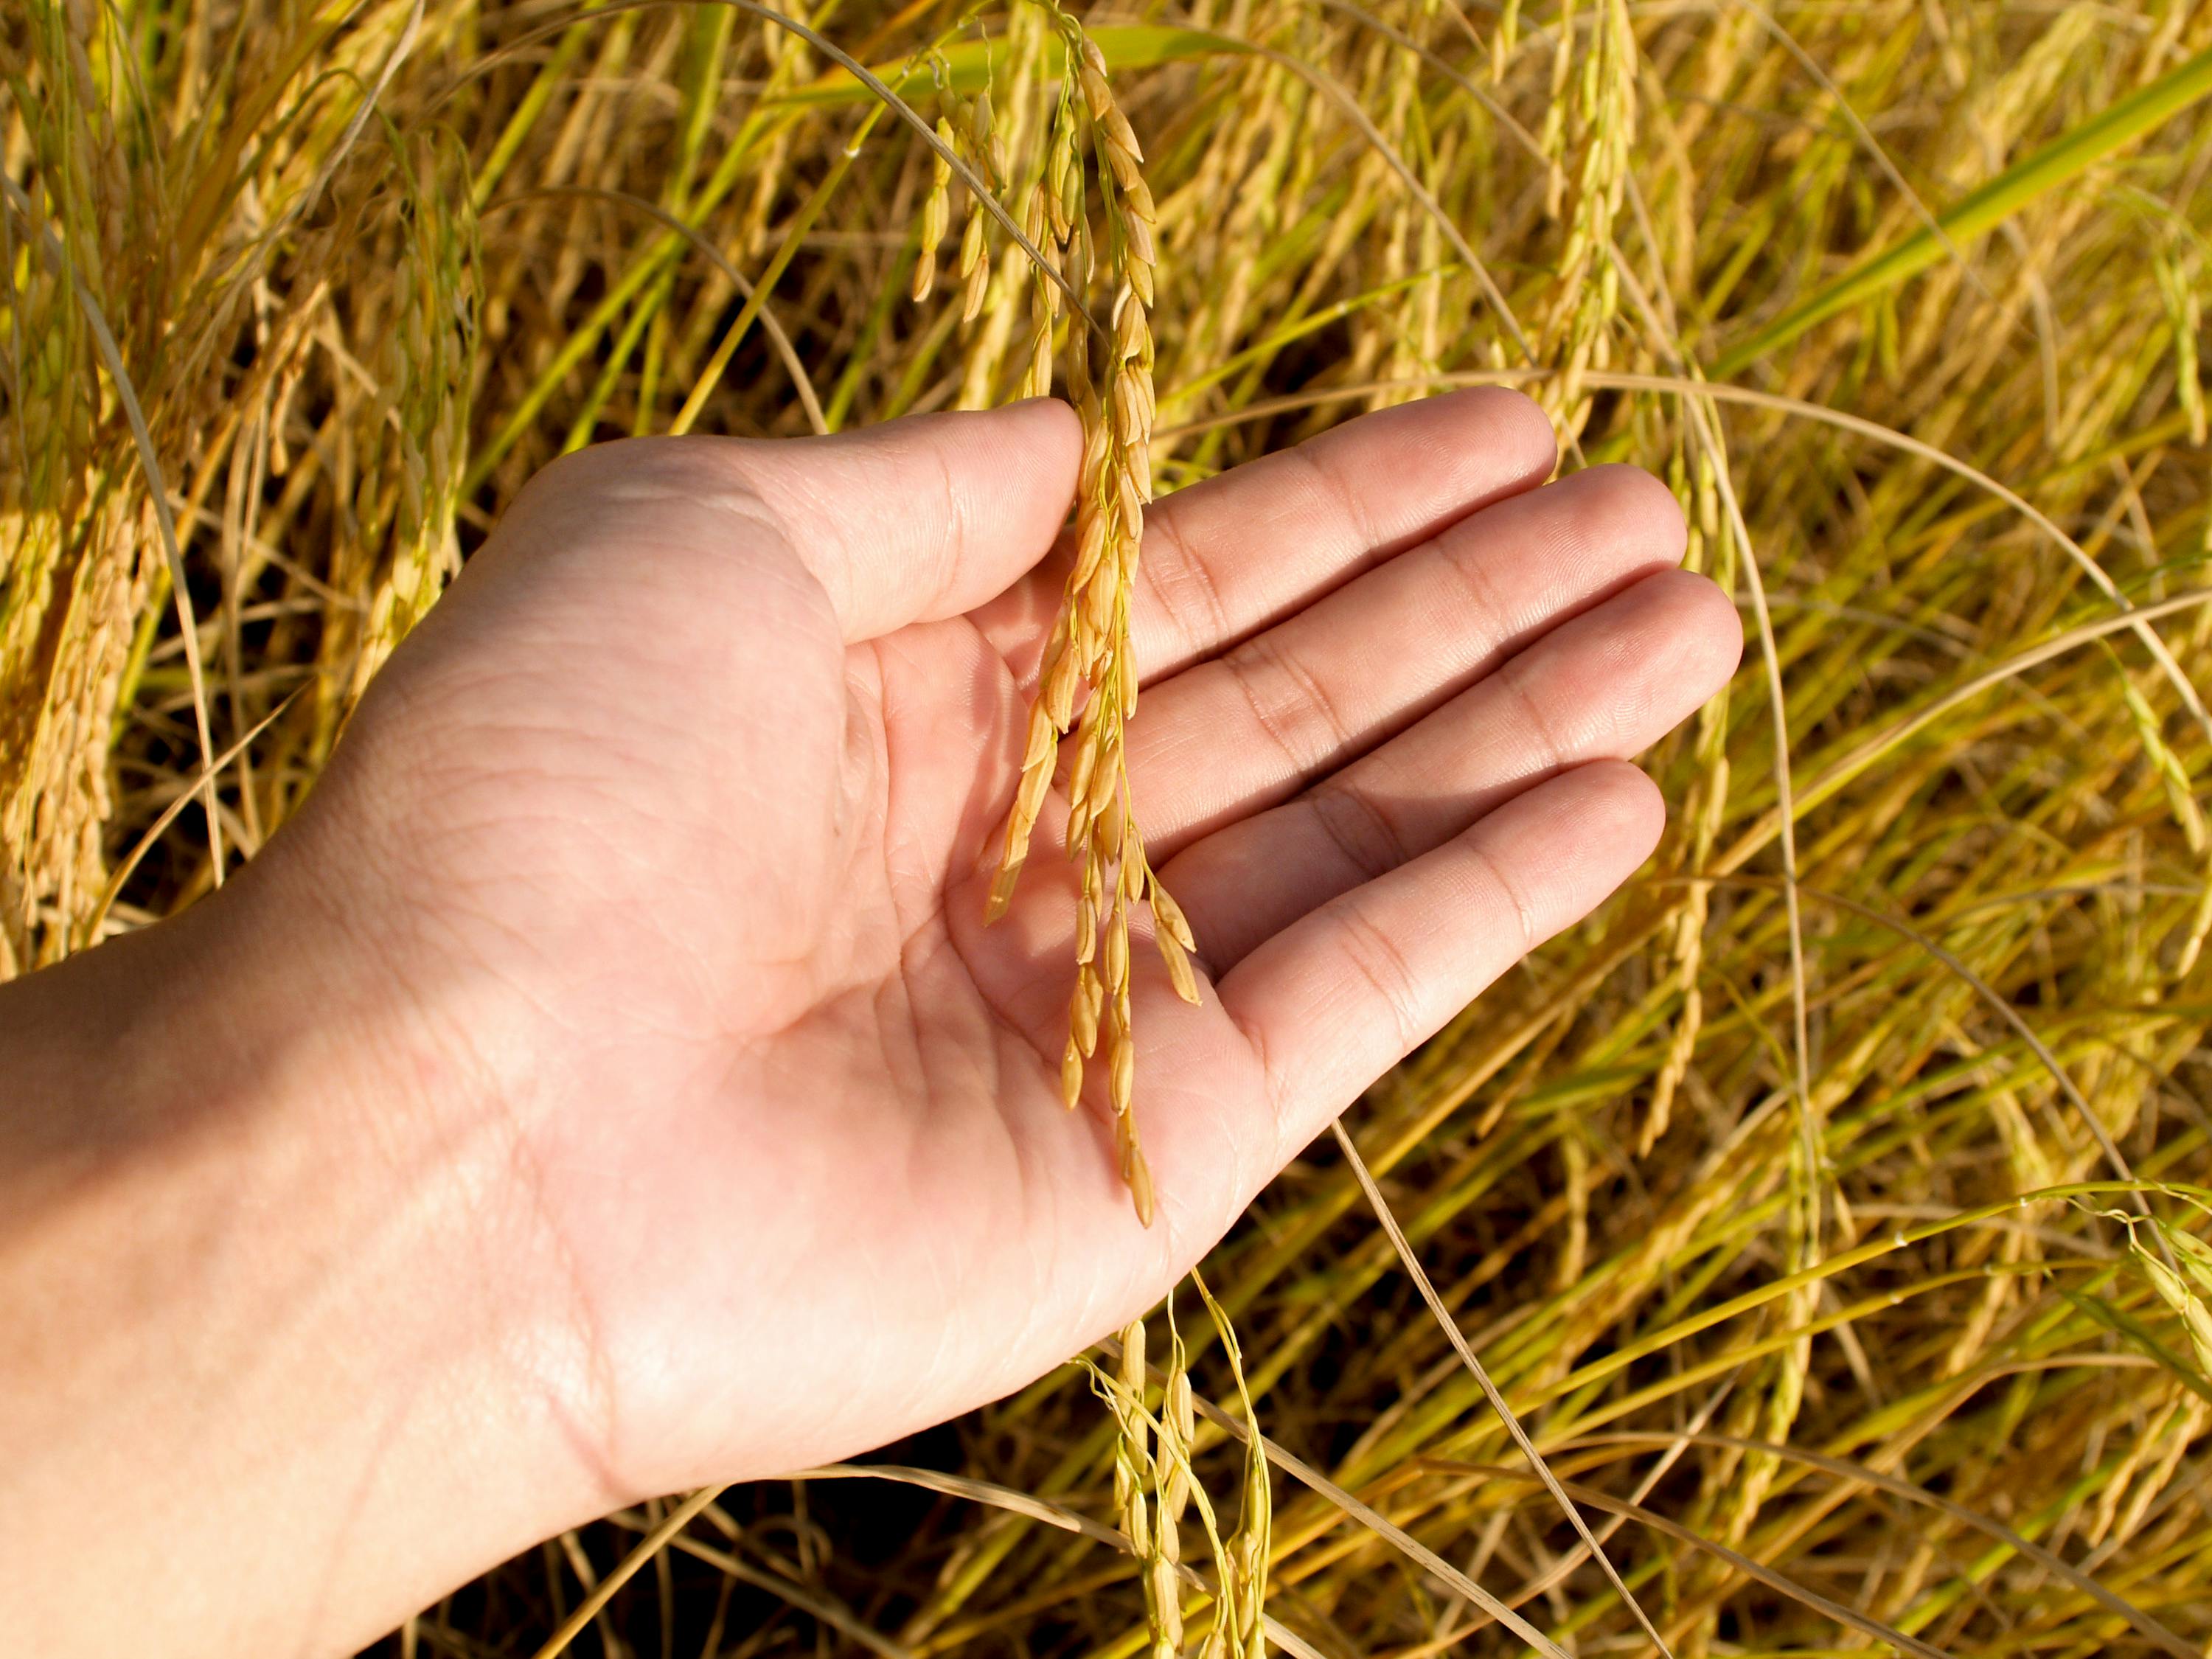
0 389 1741 1655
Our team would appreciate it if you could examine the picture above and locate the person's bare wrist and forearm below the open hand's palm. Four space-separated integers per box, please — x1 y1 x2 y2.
0 849 606 1655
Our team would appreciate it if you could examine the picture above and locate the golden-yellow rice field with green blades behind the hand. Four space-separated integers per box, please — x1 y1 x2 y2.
0 0 2212 1659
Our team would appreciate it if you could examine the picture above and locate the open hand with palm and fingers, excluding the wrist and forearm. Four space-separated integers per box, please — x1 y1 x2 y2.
254 392 1741 1498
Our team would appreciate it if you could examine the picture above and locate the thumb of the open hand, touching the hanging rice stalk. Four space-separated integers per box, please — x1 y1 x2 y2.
708 398 1084 641
